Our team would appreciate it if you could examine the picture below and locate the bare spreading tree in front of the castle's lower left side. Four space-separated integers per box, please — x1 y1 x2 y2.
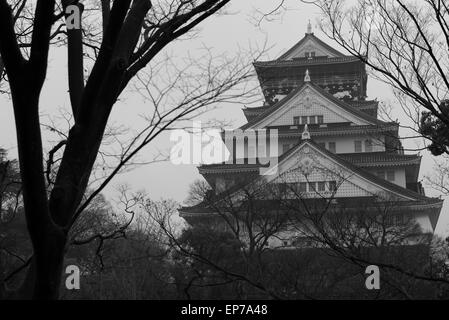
144 182 292 299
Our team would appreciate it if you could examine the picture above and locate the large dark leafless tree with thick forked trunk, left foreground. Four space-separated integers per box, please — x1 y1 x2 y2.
0 0 260 299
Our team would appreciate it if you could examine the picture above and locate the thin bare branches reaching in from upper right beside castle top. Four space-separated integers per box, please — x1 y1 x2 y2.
304 0 449 155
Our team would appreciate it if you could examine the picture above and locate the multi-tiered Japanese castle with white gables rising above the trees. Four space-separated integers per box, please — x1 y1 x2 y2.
180 23 443 248
